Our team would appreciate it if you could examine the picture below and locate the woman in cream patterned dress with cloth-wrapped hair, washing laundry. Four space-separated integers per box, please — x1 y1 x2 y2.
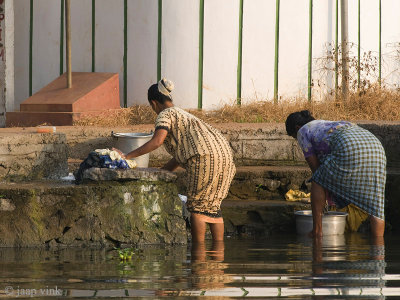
112 79 236 241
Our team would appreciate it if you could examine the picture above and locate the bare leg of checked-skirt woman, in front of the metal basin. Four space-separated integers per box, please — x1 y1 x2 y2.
311 181 325 237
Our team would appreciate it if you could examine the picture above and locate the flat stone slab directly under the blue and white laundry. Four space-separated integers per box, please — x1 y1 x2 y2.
83 168 177 182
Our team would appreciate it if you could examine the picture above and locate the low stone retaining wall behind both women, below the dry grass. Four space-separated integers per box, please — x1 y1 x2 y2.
60 122 400 167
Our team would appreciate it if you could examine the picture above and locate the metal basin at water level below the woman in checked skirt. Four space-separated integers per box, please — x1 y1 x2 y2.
294 210 348 235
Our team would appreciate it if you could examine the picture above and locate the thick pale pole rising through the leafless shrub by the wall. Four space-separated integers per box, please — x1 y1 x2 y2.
341 0 349 100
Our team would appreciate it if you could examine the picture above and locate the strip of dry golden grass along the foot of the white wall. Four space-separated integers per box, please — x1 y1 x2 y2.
76 87 400 126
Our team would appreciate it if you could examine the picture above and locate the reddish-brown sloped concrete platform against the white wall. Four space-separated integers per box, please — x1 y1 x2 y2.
6 72 120 127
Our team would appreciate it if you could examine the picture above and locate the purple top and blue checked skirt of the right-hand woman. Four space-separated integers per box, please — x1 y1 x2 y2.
297 120 386 219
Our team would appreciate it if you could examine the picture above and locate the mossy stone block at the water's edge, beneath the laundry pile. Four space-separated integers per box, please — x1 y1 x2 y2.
0 169 187 247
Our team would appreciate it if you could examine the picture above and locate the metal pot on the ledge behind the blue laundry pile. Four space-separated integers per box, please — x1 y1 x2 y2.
111 132 153 168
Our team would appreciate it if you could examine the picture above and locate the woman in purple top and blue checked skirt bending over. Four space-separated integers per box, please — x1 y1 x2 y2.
286 110 386 237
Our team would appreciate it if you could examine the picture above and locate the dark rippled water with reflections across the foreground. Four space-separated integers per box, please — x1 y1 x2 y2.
0 234 400 299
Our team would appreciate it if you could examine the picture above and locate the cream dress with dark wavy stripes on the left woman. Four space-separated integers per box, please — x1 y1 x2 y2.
155 107 236 218
